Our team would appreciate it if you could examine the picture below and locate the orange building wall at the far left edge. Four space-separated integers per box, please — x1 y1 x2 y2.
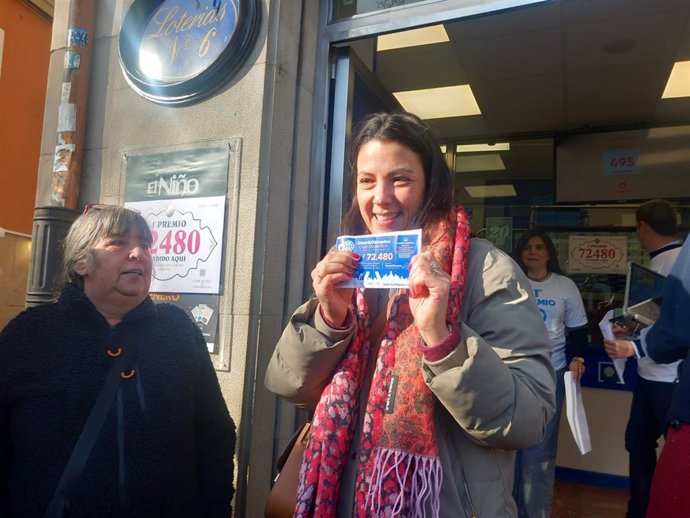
0 0 51 327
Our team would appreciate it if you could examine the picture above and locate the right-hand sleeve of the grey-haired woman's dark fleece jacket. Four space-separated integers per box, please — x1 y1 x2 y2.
190 322 236 518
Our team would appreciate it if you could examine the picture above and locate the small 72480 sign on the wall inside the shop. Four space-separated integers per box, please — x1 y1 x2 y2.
568 236 628 273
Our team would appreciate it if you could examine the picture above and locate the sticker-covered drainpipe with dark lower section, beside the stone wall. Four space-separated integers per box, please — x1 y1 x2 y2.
26 0 97 306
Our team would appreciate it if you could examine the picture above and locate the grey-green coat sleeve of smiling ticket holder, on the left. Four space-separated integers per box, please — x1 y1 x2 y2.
264 298 355 410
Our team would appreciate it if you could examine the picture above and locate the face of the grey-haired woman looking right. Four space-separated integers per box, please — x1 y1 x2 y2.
75 230 152 310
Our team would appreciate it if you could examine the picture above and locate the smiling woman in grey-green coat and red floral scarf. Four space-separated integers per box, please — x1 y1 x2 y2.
265 114 554 518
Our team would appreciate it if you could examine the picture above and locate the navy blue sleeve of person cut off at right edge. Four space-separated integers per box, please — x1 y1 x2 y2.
642 239 690 363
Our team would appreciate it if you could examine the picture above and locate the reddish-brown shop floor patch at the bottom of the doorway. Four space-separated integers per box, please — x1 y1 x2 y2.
551 480 628 518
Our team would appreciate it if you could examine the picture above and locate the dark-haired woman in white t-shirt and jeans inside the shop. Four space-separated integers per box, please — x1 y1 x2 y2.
513 229 587 518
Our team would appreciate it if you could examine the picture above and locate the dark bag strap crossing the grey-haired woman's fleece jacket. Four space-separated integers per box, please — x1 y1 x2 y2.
51 347 133 504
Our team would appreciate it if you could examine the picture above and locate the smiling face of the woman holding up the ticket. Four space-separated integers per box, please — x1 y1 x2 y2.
357 140 424 234
